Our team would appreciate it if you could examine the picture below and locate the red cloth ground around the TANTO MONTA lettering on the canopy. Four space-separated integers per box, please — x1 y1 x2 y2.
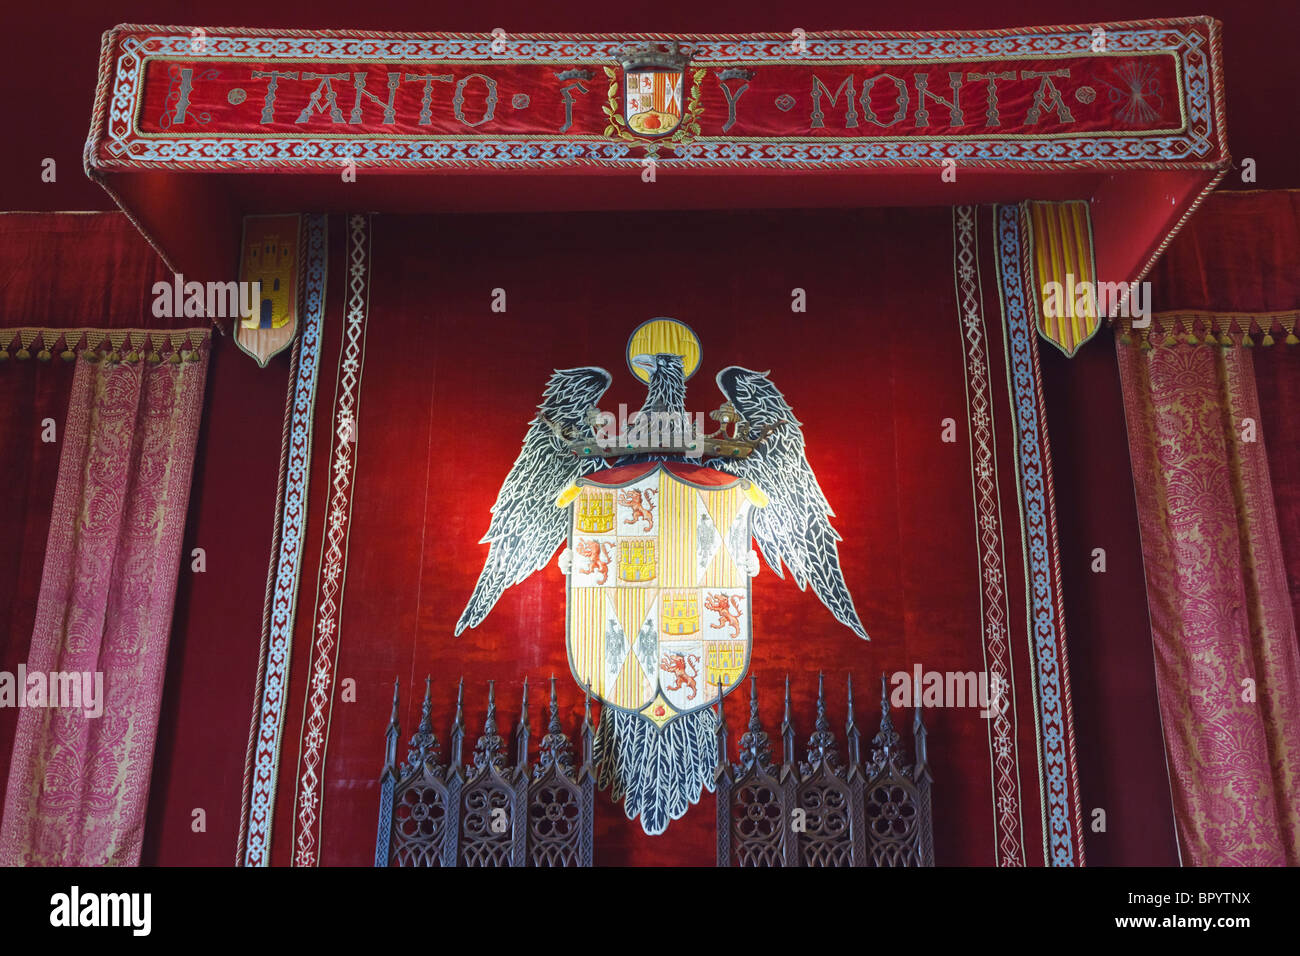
129 51 1183 140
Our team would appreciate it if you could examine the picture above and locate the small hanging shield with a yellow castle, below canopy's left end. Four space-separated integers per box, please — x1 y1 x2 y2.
234 215 302 368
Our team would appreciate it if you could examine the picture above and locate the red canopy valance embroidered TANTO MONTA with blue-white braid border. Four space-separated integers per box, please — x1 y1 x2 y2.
88 18 1226 169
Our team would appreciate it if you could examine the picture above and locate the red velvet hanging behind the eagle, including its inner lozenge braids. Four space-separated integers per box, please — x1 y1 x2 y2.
218 207 1083 865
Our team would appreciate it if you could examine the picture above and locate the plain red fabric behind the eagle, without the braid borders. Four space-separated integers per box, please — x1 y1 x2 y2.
253 209 1076 865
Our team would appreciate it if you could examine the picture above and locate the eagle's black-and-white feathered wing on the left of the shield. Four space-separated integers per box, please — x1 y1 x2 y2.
456 365 612 635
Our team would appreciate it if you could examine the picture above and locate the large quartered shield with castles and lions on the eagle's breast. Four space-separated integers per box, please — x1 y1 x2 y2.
558 462 764 726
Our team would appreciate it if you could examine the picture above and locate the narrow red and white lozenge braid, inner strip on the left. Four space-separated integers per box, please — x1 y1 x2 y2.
294 216 371 866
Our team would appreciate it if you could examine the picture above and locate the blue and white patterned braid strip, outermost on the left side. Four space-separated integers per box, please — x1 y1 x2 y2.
241 215 329 866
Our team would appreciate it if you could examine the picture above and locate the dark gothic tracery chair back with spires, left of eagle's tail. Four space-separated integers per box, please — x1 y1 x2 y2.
374 678 595 866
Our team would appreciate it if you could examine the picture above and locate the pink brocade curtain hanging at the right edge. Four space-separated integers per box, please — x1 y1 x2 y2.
1118 343 1300 866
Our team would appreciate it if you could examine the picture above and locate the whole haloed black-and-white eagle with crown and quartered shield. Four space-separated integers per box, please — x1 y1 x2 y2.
456 319 867 834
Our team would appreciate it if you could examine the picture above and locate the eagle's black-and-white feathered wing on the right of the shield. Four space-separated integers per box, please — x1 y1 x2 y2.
706 365 870 640
